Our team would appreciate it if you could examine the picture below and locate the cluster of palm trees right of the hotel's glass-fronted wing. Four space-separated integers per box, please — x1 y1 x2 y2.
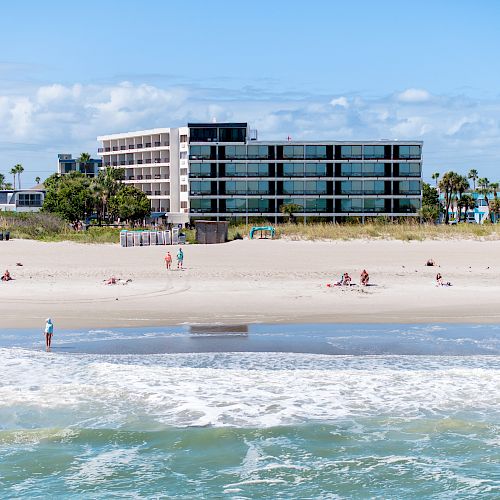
421 169 500 223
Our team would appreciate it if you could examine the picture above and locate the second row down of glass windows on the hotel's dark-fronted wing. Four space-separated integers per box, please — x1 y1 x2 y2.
190 163 422 177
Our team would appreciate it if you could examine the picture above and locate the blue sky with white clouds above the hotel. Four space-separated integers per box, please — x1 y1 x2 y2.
0 0 500 185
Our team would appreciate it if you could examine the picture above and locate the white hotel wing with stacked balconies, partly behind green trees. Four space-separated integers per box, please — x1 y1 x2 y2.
97 127 189 223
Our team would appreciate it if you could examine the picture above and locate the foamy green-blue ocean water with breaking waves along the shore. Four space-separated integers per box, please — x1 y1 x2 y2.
0 325 500 499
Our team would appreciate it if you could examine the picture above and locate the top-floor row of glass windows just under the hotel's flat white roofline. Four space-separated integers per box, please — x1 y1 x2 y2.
189 144 422 160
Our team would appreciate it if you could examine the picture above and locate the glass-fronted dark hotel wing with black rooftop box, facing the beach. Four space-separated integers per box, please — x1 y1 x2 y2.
188 123 423 221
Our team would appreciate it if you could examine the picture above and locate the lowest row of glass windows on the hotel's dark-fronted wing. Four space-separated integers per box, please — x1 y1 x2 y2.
190 198 420 213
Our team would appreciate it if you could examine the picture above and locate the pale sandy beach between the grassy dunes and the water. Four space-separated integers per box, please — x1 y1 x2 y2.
0 240 500 328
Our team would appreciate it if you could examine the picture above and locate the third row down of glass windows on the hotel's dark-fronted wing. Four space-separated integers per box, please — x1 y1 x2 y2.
190 180 421 195
